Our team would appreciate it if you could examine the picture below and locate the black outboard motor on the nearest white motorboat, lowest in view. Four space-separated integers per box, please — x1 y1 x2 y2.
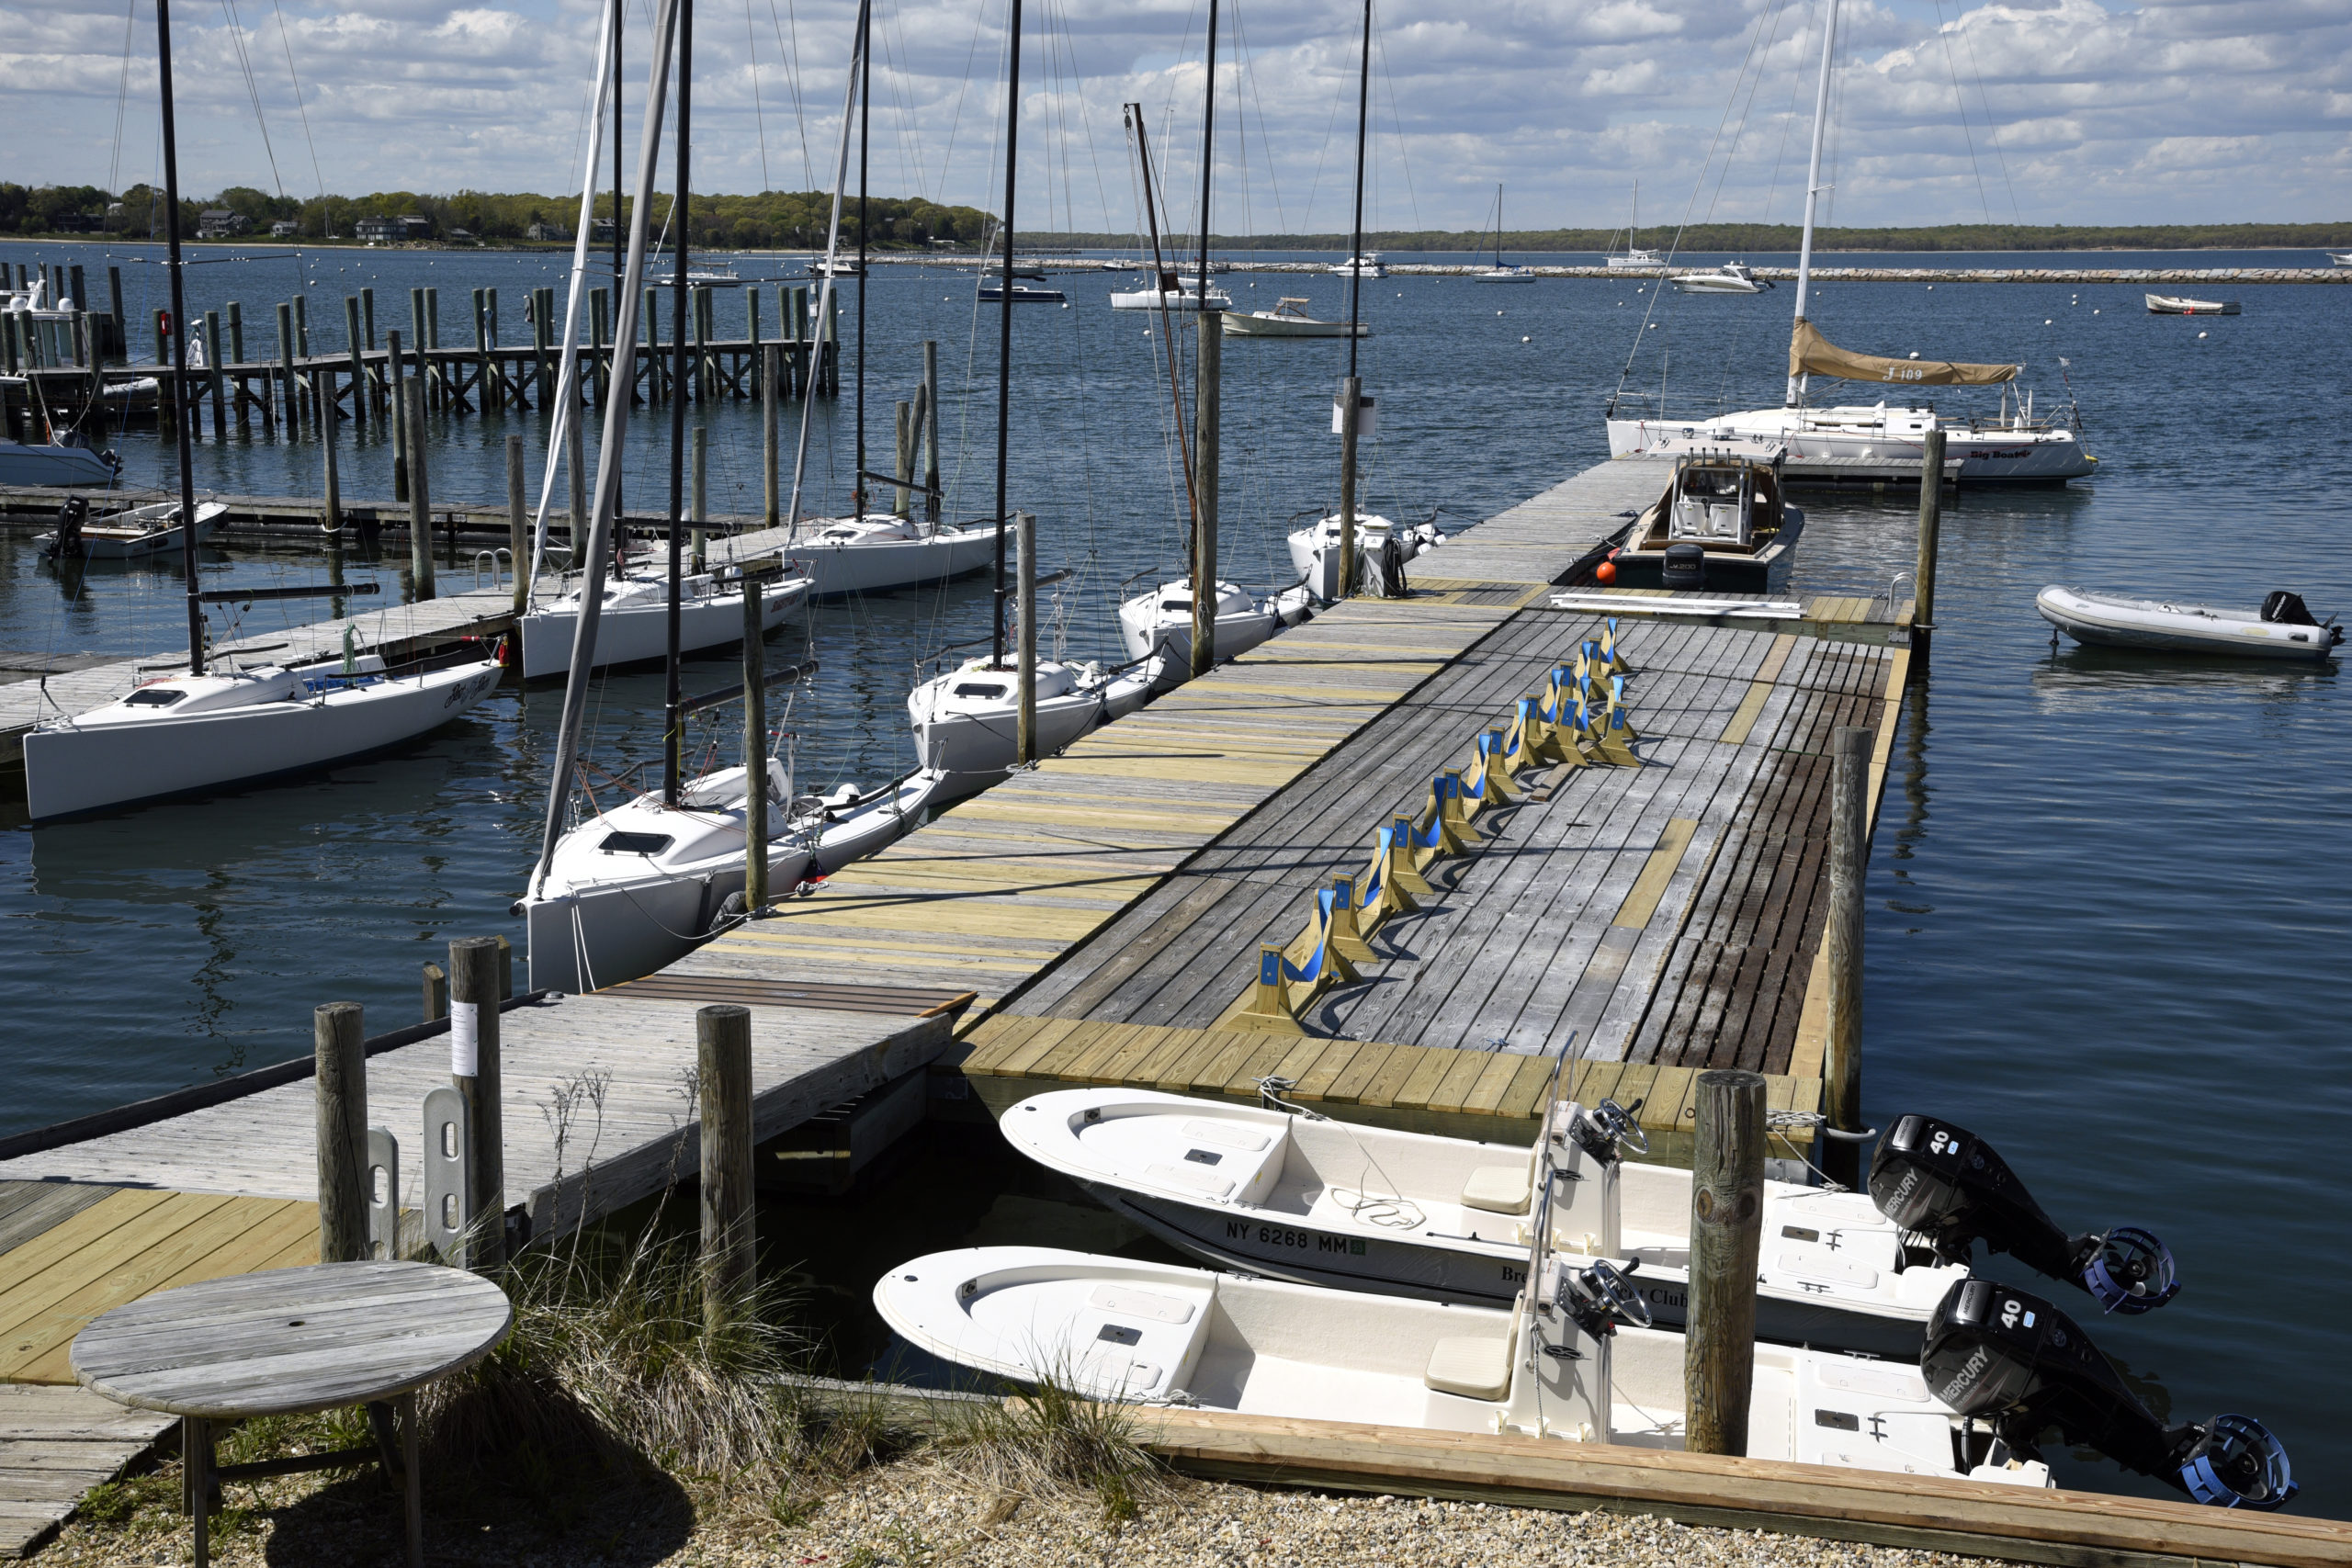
1919 1279 2298 1512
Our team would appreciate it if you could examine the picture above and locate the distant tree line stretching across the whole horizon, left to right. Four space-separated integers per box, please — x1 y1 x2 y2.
0 184 2352 259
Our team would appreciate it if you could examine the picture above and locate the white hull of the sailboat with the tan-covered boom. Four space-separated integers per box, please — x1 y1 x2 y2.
1609 409 2098 484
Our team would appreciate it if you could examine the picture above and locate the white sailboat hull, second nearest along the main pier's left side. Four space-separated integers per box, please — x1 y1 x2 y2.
906 659 1152 795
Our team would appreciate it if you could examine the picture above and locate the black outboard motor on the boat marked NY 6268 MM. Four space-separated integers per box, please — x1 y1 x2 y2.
1870 1117 2180 1316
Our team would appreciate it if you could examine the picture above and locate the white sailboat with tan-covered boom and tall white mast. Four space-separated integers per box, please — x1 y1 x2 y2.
1606 0 2098 484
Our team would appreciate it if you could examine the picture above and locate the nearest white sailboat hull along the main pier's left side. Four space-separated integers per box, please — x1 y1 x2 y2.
513 757 944 992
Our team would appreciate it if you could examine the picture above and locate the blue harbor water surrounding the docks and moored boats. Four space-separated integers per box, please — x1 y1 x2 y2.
0 247 2352 1514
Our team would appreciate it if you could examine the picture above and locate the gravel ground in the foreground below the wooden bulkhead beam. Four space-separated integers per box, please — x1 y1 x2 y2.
38 1453 2022 1568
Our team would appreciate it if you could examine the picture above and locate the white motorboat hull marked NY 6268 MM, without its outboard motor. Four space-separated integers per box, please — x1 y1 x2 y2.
1000 1089 1969 1359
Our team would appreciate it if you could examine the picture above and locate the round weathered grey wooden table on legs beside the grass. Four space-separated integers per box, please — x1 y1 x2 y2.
73 1262 515 1568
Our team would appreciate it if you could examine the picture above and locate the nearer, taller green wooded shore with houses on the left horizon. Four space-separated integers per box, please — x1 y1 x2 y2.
0 184 992 249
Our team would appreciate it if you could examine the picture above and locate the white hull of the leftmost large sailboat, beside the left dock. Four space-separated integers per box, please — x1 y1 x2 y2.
24 660 499 823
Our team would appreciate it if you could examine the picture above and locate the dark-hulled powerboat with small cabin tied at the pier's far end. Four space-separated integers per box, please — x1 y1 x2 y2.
1595 454 1804 592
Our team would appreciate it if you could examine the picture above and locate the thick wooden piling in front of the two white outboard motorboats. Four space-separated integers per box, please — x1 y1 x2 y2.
1681 1067 1764 1455
